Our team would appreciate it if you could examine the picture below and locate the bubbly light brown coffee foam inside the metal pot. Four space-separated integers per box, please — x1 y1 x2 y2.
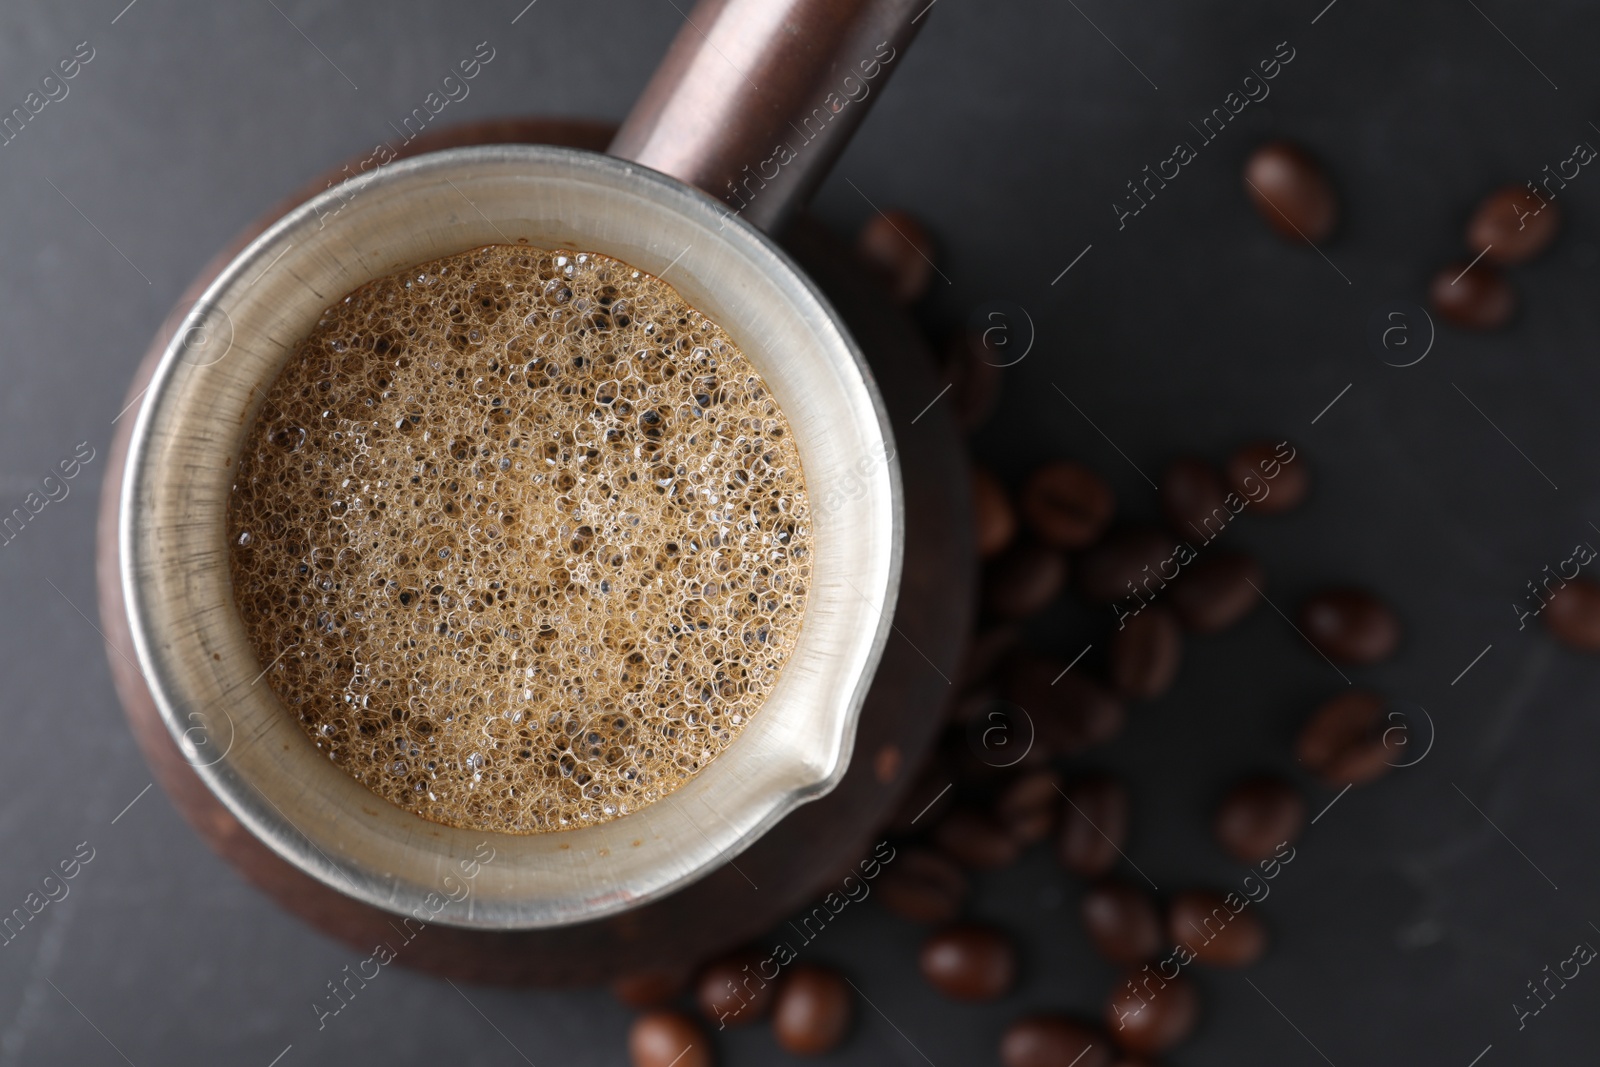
227 245 811 833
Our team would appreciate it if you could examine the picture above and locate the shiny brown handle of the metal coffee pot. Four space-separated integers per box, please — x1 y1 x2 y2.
610 0 933 234
